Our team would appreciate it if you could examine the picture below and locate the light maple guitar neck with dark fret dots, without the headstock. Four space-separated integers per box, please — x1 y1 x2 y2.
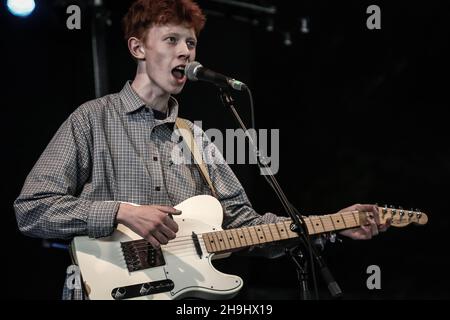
202 211 365 253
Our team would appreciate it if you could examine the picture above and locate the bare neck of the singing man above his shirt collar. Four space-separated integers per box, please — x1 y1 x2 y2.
131 67 170 113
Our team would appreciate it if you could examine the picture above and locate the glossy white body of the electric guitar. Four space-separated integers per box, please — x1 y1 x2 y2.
72 195 243 300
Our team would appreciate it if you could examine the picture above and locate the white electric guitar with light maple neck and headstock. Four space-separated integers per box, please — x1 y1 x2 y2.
72 195 428 300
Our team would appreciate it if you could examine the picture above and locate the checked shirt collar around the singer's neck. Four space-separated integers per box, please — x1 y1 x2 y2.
119 81 178 122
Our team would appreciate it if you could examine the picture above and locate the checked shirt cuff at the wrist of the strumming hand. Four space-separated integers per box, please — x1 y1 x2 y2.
87 201 120 238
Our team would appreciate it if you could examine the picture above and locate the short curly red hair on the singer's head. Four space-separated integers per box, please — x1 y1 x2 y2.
122 0 206 41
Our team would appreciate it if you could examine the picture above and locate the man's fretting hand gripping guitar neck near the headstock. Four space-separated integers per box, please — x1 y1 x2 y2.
338 204 391 240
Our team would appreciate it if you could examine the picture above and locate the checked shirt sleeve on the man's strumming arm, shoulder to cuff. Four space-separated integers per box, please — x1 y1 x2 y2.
14 113 119 239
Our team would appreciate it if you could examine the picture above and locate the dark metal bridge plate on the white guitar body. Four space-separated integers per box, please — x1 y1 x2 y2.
120 240 166 272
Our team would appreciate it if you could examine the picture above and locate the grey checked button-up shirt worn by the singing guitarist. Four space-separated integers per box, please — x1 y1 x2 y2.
14 82 296 298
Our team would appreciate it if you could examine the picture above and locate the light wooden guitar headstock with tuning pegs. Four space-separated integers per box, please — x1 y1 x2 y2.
378 206 428 227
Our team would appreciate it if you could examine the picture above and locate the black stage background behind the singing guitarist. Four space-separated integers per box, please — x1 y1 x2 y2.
0 0 450 299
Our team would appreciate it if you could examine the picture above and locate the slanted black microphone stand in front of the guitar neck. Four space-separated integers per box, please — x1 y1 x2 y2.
219 87 342 300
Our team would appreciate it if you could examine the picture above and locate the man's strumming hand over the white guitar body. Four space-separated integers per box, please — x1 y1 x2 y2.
116 203 181 249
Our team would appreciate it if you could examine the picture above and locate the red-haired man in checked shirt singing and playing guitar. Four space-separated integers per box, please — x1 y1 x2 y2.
14 0 387 300
